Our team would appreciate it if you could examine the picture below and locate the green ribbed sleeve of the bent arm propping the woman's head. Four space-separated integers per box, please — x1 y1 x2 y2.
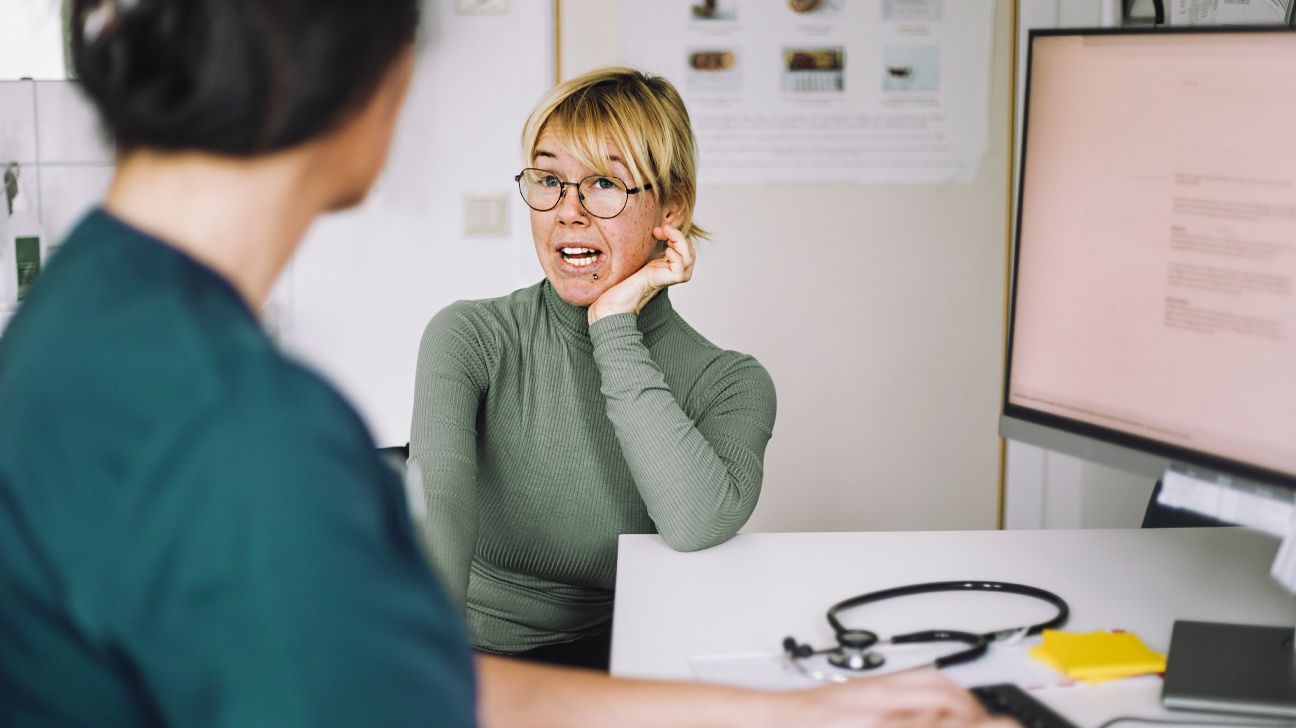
590 313 775 551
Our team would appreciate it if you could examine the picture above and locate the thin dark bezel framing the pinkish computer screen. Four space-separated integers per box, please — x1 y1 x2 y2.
1001 25 1296 491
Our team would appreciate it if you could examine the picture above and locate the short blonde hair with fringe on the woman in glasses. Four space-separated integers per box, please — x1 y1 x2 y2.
522 66 708 238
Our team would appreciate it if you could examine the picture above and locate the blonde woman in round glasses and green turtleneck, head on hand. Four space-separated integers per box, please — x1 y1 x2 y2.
411 69 775 668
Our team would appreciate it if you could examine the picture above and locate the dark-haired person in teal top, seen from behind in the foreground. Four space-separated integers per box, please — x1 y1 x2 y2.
0 0 1000 727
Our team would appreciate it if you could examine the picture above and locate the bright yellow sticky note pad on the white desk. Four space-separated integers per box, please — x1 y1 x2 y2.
1030 630 1165 683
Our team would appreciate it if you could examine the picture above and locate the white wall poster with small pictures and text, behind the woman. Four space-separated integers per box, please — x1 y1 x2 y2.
621 0 994 185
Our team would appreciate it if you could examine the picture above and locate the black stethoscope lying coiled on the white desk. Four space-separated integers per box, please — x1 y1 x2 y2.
783 582 1070 681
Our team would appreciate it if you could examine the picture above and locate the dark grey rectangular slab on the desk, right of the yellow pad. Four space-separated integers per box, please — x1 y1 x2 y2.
1161 619 1296 718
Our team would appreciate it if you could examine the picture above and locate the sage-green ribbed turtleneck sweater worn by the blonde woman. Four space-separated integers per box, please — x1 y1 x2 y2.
411 281 775 653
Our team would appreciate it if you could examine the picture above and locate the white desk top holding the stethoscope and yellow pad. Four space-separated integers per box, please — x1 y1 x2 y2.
612 529 1296 725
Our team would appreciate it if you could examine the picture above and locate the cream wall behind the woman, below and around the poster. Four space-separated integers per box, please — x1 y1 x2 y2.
561 0 1012 531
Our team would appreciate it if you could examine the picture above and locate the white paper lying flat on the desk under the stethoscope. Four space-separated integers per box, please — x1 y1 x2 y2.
689 637 1073 690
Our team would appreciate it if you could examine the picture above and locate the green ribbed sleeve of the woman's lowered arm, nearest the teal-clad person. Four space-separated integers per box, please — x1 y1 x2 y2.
410 303 494 615
